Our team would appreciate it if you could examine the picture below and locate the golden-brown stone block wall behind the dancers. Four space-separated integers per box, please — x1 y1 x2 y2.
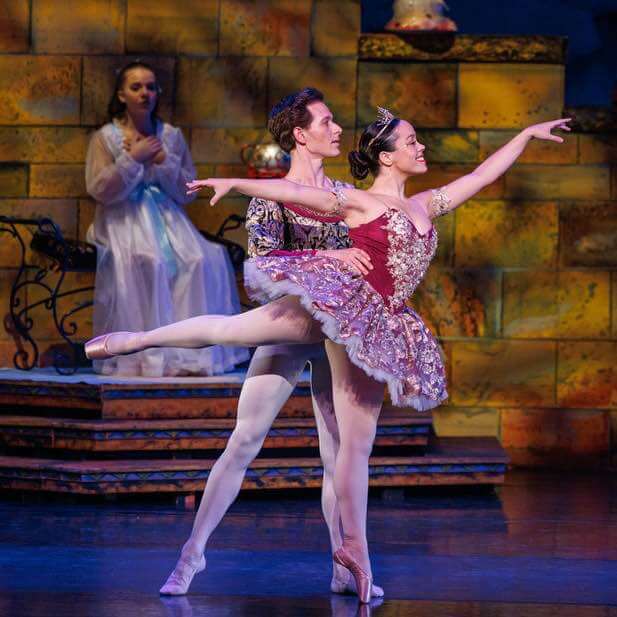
0 0 617 466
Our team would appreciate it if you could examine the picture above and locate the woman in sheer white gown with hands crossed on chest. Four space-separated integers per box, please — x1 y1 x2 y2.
86 62 248 377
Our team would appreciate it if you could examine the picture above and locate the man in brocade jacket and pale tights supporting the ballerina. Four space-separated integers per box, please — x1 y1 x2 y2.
160 88 383 596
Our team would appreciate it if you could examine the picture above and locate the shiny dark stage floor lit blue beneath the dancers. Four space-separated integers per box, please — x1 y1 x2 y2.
0 471 617 617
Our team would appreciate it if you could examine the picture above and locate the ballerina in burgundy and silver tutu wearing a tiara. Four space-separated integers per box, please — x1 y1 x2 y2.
86 110 570 603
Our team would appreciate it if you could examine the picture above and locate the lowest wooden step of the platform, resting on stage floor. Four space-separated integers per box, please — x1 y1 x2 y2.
0 438 507 494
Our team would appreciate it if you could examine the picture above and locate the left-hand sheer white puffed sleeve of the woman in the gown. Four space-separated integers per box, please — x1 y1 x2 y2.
86 131 144 204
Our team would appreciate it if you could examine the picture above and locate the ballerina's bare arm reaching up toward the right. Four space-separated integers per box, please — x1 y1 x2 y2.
414 118 571 218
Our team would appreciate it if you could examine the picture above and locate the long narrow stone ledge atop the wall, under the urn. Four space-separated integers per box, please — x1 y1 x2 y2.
358 32 567 64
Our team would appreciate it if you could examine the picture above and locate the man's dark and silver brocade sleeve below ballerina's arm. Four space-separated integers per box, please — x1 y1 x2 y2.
246 197 285 257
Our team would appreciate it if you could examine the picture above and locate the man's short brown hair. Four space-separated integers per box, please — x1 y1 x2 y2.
268 88 324 152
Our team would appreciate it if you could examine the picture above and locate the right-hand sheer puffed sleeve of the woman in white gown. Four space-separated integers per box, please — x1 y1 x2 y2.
152 127 197 205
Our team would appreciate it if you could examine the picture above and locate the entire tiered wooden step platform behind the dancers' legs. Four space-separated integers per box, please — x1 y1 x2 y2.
0 369 507 494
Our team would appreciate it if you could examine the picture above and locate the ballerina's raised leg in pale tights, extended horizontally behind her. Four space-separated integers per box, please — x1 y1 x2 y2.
105 296 324 354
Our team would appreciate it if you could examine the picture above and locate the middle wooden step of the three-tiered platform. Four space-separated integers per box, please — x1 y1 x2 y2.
0 407 432 452
